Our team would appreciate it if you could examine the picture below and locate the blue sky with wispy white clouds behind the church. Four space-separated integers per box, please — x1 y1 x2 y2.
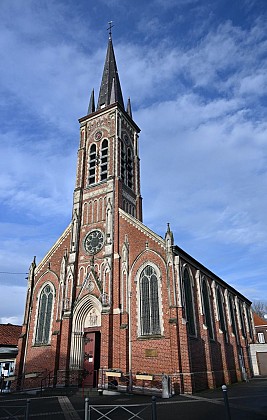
0 0 267 323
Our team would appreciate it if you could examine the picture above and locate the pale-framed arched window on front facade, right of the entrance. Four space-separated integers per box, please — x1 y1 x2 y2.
140 265 161 336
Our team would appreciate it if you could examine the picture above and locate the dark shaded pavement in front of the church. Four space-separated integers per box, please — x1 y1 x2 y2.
0 377 267 420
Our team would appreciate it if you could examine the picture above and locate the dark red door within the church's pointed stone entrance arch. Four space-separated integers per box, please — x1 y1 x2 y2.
83 331 100 387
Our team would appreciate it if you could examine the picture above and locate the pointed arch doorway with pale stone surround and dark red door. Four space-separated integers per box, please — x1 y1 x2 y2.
70 295 102 387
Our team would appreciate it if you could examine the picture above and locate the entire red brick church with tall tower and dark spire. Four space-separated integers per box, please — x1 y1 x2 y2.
16 35 254 393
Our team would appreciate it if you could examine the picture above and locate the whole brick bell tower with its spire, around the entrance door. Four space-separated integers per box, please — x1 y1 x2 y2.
65 34 142 374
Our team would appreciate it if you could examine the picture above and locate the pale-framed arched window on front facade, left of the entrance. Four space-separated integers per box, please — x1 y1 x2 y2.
35 284 53 344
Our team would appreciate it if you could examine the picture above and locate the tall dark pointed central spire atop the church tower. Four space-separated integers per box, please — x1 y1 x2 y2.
97 36 124 110
